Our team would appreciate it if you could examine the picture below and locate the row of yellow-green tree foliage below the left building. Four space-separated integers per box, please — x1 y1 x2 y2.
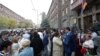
0 16 33 29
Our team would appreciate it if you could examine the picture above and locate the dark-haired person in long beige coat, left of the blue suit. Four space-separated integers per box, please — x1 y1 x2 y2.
53 32 63 56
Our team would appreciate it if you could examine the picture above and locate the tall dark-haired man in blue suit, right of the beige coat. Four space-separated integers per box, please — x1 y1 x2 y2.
63 27 75 56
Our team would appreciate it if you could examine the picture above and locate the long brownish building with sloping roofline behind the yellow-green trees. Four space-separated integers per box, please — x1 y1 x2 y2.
0 4 35 27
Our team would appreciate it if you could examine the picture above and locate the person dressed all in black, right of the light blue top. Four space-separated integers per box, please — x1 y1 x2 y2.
30 32 44 56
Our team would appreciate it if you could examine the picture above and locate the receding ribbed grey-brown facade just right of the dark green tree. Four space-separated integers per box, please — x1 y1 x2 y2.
47 0 60 28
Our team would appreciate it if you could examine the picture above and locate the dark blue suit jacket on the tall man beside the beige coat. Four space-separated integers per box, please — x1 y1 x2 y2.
63 32 76 53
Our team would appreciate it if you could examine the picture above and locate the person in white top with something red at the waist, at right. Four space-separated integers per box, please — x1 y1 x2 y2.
81 33 94 56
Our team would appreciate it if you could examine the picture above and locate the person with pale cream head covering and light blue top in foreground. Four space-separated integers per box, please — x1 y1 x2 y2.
17 39 34 56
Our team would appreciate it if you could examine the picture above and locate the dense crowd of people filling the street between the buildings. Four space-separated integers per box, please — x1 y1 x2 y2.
0 27 100 56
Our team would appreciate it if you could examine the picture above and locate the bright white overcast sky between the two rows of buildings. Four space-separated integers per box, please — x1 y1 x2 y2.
0 0 52 24
